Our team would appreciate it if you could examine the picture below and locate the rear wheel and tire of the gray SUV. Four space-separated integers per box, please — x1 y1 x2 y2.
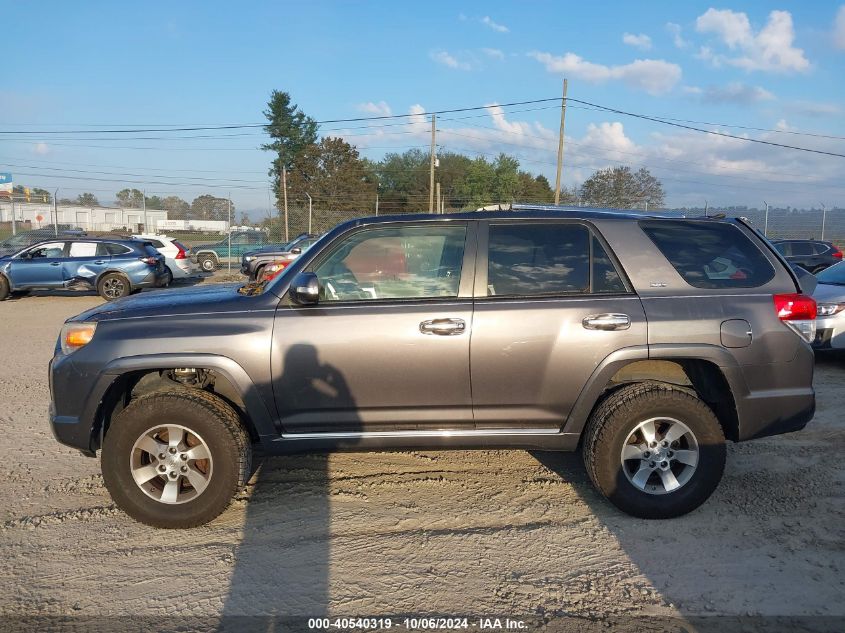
583 382 726 519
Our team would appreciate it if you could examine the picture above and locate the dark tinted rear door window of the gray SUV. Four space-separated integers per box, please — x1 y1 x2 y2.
487 223 625 296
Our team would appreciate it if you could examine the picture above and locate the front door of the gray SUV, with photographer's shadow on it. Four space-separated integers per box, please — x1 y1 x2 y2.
272 221 475 433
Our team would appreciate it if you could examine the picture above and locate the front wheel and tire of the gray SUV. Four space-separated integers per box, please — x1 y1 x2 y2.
101 389 252 528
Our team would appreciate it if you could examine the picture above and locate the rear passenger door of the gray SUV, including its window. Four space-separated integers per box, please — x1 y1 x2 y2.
470 220 647 432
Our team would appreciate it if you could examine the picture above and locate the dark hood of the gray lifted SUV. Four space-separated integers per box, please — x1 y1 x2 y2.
70 283 278 321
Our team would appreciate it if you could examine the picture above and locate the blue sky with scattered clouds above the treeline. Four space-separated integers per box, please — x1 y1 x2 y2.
0 0 845 217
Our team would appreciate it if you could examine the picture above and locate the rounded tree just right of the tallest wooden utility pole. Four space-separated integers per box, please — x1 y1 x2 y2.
581 166 665 209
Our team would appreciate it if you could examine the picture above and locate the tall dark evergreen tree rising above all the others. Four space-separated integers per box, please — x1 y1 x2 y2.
261 90 317 209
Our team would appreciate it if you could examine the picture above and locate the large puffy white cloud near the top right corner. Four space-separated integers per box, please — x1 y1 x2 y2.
695 7 810 72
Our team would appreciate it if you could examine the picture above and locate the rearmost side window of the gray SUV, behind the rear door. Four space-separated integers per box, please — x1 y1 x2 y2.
640 220 775 289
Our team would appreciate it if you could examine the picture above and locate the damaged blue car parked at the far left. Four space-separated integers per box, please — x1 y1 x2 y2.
0 237 168 301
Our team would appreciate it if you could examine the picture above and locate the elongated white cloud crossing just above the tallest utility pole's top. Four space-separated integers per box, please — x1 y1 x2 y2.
528 51 681 95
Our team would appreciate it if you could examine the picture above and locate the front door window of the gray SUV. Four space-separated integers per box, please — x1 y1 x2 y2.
314 225 466 302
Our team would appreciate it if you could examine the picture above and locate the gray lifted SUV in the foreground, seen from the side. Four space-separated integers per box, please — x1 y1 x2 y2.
50 208 816 528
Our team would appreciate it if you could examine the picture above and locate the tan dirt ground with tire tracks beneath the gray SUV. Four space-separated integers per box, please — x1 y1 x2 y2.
0 288 845 622
